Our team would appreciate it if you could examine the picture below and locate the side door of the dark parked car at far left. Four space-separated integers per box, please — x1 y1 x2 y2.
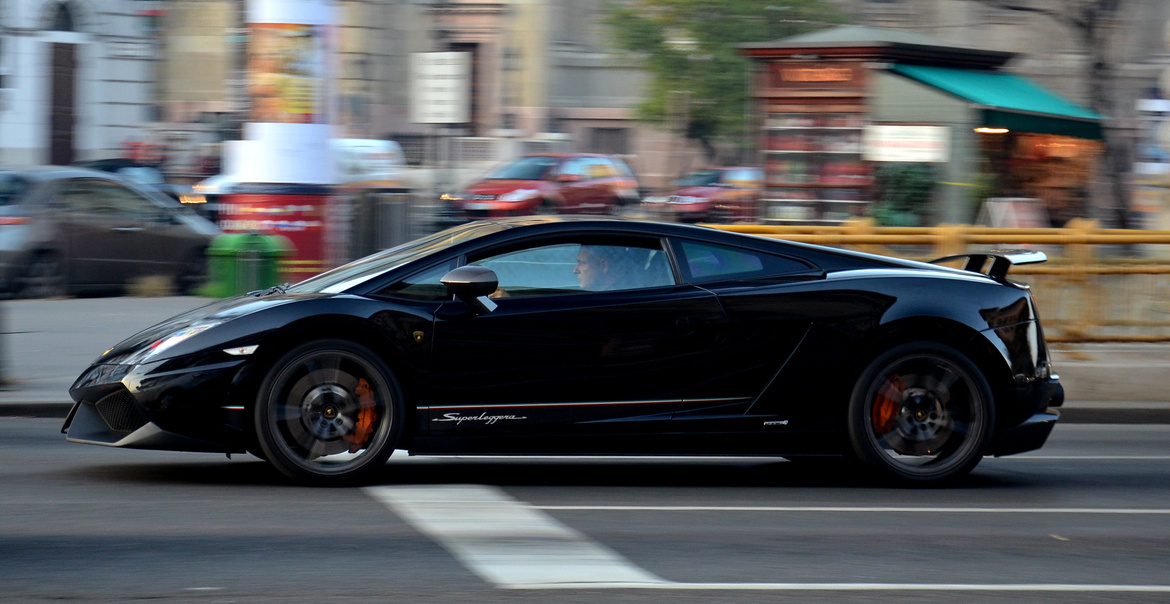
55 178 142 287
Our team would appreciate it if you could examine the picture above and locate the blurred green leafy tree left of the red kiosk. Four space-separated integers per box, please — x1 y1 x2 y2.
606 0 846 157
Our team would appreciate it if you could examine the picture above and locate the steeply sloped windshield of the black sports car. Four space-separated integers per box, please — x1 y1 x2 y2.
288 222 507 294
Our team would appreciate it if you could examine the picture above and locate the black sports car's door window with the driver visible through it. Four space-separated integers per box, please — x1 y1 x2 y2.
472 242 675 297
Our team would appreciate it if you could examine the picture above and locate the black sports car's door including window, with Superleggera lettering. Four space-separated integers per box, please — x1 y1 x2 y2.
425 238 724 435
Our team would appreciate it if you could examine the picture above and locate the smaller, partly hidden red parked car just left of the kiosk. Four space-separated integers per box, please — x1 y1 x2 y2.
645 167 764 222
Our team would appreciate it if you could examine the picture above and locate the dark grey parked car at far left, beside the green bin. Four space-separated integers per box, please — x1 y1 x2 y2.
0 166 219 297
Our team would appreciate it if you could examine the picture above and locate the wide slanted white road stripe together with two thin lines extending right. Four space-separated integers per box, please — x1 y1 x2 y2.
365 485 1170 593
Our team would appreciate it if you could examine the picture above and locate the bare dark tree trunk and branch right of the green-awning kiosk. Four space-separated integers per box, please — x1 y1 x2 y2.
971 0 1133 228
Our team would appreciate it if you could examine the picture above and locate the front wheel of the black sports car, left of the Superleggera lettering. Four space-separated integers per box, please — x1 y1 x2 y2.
254 339 405 485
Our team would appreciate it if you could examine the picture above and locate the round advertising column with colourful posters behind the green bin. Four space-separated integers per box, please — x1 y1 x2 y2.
220 0 336 282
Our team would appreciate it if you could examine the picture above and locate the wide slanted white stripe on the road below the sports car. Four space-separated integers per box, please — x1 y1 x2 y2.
365 485 666 589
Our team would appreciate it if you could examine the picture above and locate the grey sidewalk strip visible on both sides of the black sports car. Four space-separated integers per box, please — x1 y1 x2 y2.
0 296 1170 424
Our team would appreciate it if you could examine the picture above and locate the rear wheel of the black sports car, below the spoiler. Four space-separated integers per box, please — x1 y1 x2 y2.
848 342 996 485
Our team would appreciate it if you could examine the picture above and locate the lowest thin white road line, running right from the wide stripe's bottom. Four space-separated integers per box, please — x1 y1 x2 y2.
508 582 1170 593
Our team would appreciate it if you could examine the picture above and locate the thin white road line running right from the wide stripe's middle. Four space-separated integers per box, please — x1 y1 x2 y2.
532 506 1170 515
